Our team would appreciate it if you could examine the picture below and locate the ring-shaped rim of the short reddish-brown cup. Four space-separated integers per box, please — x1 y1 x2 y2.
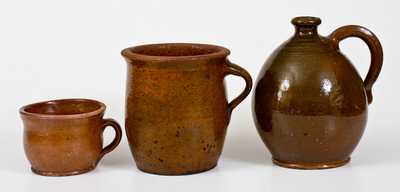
19 98 106 119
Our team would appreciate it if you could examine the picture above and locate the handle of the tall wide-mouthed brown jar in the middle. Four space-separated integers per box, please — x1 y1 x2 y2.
225 60 253 114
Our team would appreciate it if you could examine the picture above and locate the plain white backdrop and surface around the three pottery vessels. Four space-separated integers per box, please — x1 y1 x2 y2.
0 0 400 192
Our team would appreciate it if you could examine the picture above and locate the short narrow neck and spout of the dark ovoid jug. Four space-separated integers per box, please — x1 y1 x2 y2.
292 16 321 39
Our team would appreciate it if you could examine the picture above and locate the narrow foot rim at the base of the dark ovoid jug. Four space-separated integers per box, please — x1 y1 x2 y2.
272 157 350 169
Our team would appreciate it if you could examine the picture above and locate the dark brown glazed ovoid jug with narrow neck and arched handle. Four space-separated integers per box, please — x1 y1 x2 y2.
253 17 383 169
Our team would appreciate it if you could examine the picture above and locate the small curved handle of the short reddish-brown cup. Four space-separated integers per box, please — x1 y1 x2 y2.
96 119 122 164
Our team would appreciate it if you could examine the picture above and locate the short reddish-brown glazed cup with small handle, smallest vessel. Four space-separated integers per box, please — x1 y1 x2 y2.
20 99 122 176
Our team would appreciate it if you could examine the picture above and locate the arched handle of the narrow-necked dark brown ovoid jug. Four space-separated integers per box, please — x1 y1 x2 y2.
328 25 383 104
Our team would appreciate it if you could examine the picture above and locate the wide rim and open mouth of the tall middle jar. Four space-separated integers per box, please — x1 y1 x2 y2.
121 43 230 61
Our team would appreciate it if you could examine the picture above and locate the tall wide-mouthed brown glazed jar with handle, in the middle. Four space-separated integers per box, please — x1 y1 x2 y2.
122 43 252 175
